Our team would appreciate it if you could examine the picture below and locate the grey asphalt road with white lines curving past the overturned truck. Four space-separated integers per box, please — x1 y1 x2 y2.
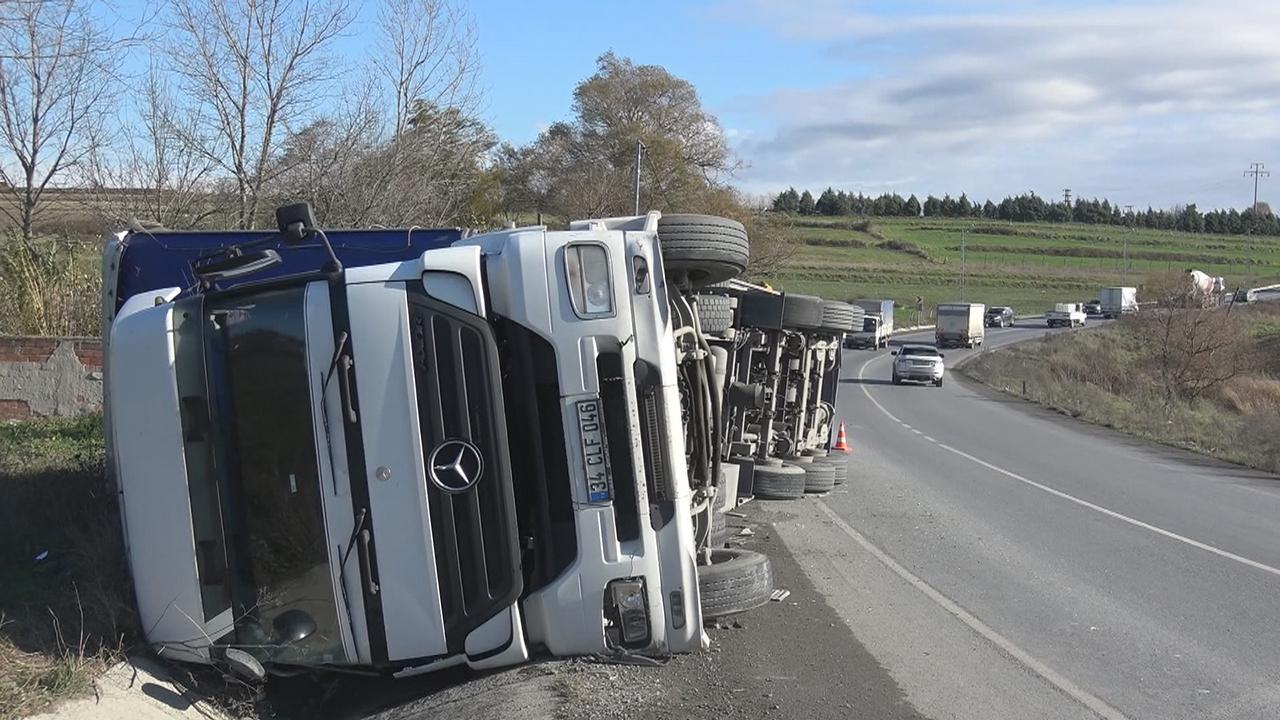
778 322 1280 719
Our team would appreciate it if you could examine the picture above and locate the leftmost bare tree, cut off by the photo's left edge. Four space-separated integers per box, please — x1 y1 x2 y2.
0 0 120 245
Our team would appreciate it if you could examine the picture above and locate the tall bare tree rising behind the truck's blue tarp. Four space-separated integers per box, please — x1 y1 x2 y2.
168 0 351 228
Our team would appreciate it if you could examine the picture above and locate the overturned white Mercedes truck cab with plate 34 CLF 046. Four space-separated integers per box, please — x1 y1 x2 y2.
104 205 772 679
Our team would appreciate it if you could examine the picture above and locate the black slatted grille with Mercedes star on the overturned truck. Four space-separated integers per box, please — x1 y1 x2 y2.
408 283 522 653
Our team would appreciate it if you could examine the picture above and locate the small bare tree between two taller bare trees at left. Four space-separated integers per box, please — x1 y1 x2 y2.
84 67 221 228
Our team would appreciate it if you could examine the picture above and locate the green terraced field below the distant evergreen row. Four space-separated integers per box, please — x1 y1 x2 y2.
769 217 1280 323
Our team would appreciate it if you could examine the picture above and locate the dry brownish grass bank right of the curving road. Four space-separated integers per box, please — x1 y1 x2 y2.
963 309 1280 473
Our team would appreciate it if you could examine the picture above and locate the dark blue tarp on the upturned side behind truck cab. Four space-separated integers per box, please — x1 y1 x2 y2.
115 228 462 309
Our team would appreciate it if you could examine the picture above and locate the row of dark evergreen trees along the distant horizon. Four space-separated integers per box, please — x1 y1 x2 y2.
772 187 1280 234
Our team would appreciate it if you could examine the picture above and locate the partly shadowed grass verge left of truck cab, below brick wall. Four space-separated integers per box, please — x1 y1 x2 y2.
0 416 134 720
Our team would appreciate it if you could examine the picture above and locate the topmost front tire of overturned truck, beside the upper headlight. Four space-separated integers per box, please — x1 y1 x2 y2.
658 214 750 290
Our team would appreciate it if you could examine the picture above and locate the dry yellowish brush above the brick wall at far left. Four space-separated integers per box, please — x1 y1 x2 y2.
0 233 101 336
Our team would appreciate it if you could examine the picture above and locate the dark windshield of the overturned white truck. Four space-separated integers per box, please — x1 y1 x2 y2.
178 287 346 665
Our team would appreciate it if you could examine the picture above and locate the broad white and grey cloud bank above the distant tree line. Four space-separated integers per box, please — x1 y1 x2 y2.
713 0 1280 205
